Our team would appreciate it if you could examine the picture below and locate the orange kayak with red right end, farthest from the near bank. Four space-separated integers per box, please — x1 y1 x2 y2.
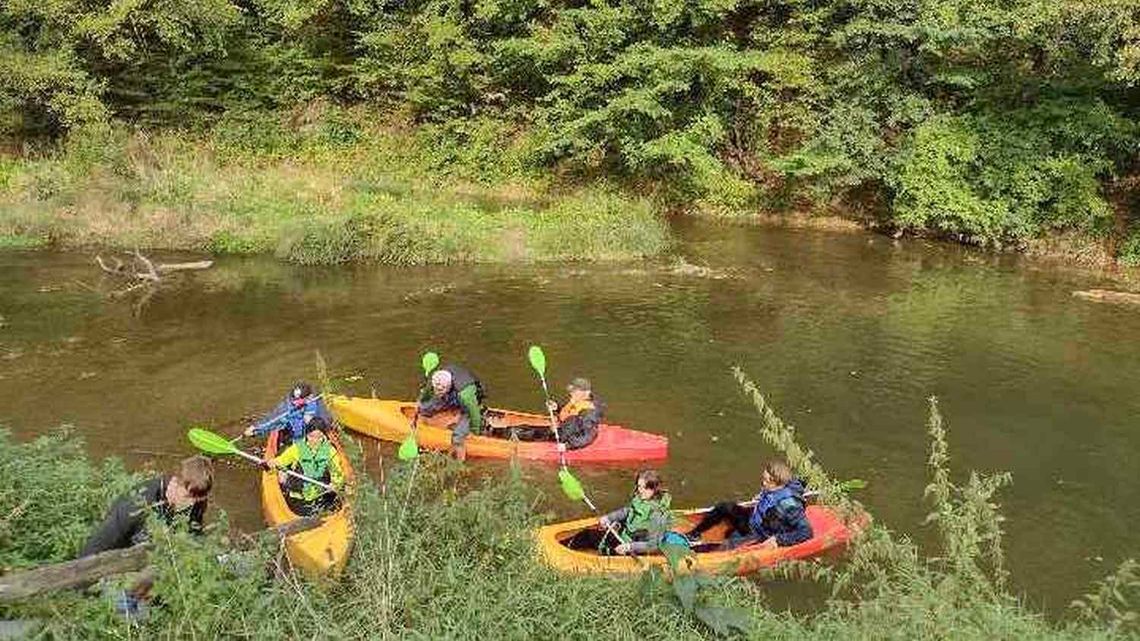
326 396 669 463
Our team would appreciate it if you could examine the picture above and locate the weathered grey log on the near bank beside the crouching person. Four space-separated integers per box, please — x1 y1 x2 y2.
0 517 321 603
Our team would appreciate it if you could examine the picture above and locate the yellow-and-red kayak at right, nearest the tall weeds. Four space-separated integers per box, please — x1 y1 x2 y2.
536 505 868 575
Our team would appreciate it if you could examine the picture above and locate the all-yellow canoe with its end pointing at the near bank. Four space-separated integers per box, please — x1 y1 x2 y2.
261 432 352 577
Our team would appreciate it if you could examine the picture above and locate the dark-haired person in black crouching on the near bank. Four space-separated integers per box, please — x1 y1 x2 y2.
79 456 213 558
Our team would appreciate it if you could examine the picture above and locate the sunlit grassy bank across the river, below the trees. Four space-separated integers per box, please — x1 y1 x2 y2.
0 105 668 265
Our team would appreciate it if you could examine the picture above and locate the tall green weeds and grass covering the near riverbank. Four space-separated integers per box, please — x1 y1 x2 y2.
0 375 1140 640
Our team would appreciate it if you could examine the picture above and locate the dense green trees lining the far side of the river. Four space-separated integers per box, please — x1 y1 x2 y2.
0 0 1140 254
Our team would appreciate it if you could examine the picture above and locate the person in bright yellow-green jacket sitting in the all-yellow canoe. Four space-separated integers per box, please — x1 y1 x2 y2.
268 416 344 517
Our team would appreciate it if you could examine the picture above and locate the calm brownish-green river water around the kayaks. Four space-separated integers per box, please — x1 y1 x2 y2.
0 221 1140 616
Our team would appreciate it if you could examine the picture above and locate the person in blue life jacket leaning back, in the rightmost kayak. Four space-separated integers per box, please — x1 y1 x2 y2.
687 460 812 547
